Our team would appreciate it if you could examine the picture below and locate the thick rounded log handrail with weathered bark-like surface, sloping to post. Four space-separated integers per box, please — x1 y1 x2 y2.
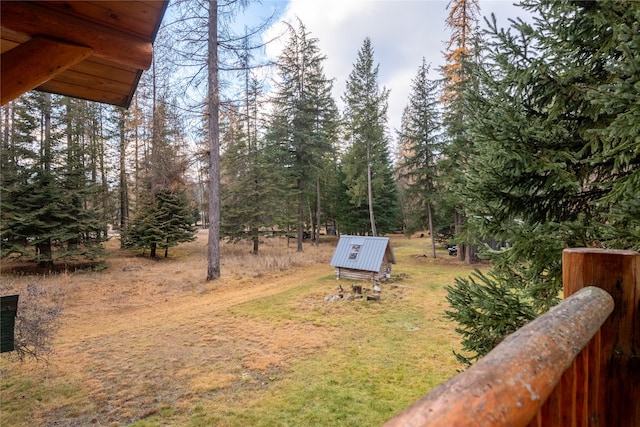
385 287 613 427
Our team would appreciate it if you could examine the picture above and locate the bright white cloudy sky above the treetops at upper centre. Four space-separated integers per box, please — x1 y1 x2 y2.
239 0 525 139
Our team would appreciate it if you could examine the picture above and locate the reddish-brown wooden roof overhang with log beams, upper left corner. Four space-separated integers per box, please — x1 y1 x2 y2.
0 0 169 107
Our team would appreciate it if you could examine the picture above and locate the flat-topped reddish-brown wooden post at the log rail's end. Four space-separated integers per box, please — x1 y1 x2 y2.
562 248 640 427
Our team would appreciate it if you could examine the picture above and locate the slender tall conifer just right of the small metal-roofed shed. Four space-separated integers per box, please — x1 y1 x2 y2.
399 58 442 258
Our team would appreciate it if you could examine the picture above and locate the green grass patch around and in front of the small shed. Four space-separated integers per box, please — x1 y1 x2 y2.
189 242 471 426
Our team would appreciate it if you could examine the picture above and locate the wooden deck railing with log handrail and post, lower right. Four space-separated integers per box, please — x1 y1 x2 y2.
385 249 640 427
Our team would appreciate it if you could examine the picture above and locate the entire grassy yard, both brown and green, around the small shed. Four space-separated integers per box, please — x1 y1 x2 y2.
0 234 478 426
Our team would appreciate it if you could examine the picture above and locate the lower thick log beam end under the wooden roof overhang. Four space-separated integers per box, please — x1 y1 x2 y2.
0 37 93 105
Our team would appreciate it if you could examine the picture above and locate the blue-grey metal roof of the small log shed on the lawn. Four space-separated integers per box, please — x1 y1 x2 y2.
331 235 396 271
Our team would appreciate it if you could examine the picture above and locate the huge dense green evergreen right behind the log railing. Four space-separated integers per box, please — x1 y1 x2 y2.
448 0 640 366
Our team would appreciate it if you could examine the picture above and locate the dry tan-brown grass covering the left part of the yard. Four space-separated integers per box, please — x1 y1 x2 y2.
0 233 470 426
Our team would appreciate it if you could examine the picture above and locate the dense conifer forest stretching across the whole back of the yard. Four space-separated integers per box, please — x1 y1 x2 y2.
0 0 640 361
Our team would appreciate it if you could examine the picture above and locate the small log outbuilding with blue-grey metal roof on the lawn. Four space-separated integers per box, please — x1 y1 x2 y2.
331 235 396 282
